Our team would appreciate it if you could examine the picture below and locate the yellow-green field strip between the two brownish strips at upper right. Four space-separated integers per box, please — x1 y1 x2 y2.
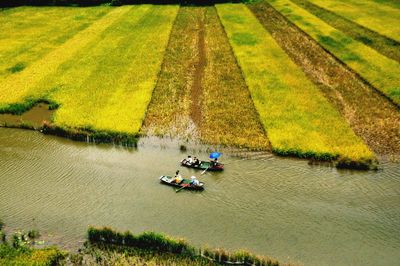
266 0 400 106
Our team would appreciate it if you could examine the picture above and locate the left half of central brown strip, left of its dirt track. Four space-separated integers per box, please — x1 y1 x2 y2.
142 7 202 137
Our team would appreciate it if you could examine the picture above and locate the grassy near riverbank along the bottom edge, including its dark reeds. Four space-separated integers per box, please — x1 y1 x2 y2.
0 220 284 266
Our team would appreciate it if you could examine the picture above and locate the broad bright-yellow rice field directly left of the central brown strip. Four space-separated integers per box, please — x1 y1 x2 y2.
0 5 178 134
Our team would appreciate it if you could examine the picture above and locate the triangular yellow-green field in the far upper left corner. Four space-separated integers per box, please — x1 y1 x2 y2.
0 7 111 82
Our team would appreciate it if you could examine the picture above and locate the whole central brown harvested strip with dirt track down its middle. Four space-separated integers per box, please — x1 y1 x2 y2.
143 7 269 150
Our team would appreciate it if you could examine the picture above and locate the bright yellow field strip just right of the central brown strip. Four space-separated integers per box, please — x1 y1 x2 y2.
216 4 374 162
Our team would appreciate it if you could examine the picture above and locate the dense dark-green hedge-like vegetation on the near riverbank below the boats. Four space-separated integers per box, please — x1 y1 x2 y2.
88 227 279 266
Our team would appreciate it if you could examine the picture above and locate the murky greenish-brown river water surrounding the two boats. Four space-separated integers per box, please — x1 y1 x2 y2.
0 128 400 265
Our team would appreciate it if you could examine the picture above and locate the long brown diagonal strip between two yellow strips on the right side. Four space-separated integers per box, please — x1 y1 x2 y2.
249 3 400 158
